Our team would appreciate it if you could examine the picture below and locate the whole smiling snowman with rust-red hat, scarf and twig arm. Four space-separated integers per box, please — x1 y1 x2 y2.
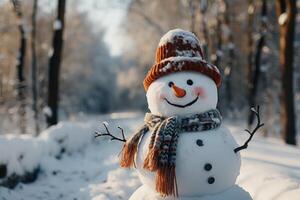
96 29 262 200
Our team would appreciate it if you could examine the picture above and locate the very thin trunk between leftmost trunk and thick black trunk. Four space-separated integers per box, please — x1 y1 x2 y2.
31 0 40 135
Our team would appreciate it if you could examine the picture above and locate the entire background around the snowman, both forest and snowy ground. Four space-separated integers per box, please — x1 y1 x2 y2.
0 0 300 200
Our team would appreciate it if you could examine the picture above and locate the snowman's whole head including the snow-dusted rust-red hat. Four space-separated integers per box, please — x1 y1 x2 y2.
144 29 221 117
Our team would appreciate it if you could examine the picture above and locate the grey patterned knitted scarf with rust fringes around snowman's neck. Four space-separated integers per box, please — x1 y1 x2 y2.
120 109 222 196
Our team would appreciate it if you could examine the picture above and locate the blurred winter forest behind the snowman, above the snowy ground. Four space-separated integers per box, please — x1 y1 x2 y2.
0 0 300 144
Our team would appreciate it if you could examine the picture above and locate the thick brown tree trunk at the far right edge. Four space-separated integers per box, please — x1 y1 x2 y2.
276 0 296 145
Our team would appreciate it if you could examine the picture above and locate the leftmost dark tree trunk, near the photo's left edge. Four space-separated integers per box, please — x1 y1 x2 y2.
12 0 27 133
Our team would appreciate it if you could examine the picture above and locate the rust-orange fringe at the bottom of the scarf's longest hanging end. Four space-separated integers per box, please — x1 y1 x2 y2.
155 166 178 197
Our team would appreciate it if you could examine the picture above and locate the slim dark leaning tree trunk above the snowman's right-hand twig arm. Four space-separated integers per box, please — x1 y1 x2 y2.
248 0 267 126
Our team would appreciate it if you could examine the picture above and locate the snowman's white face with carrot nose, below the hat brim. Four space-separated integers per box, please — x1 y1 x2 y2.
147 72 218 117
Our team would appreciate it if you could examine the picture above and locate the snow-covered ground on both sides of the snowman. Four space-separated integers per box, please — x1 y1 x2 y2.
0 113 300 200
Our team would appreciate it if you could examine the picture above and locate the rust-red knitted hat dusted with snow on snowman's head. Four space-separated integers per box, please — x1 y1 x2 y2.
144 29 221 91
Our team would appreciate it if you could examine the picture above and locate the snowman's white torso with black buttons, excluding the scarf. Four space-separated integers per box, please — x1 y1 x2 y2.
136 126 241 197
